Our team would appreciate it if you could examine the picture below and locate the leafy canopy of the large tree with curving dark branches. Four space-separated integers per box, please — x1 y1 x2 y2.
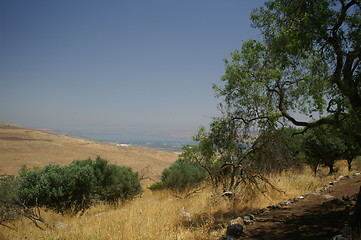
214 0 361 138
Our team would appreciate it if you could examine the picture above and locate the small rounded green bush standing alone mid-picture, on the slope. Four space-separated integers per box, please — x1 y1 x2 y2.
157 157 207 191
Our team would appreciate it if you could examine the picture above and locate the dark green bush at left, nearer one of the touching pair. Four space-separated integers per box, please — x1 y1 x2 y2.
19 165 95 212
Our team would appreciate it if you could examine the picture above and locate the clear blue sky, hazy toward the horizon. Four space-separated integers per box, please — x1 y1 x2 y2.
0 0 264 136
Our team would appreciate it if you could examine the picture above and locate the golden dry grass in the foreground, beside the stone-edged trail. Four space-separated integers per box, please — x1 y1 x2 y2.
0 161 358 240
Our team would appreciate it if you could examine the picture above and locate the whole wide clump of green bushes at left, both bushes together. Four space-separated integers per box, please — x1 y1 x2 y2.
18 156 141 213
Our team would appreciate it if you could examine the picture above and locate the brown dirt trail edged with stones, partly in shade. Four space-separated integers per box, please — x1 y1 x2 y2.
242 176 361 240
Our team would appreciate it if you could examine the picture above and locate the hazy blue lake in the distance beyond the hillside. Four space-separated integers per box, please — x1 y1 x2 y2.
70 132 195 152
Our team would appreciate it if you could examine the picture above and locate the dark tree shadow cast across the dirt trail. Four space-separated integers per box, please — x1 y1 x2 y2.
244 200 350 240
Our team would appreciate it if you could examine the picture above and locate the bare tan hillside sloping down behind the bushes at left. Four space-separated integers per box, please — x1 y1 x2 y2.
0 122 177 183
